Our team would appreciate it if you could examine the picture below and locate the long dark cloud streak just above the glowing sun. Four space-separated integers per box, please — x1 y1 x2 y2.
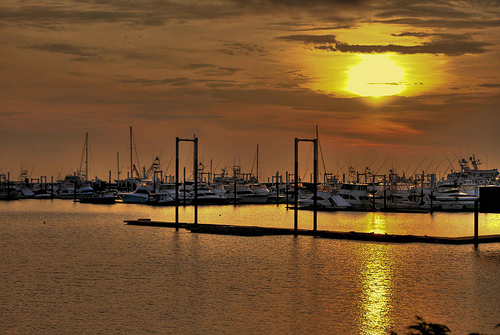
278 35 491 56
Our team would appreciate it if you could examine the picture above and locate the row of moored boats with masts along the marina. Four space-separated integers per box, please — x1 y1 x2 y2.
0 135 500 213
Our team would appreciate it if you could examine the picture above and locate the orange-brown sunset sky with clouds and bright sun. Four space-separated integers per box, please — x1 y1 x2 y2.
0 0 500 180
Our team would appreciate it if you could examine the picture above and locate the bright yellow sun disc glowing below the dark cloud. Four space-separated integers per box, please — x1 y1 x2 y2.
345 55 405 97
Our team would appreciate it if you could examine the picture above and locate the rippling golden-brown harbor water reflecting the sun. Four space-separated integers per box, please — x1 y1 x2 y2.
0 200 500 334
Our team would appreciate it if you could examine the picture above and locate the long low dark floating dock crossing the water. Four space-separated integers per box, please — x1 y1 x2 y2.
124 219 500 245
